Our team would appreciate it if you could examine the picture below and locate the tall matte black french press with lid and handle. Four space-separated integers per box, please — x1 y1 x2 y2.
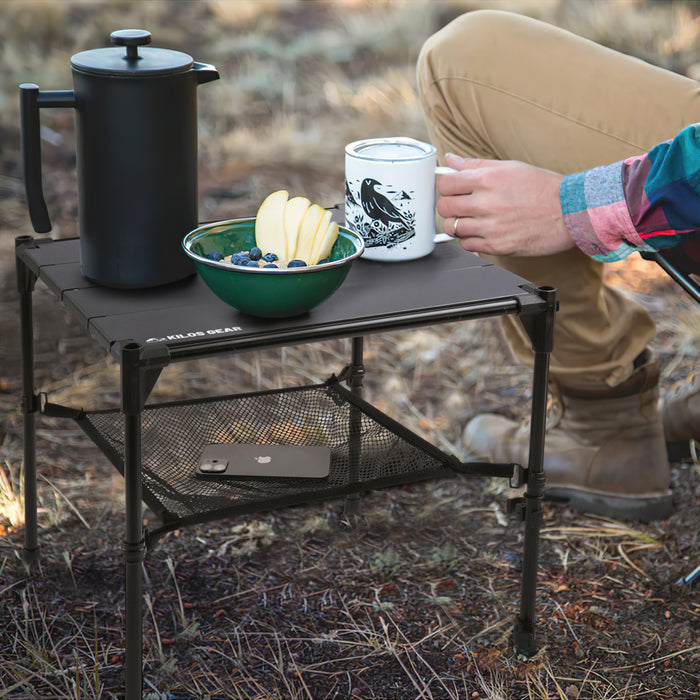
20 29 219 289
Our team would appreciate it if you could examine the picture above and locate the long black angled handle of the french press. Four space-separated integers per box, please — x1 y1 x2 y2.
19 83 75 233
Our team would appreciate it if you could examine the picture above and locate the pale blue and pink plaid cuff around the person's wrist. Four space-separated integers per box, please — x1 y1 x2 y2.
559 161 648 262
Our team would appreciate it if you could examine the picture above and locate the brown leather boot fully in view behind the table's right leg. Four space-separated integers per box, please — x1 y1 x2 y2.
464 354 672 522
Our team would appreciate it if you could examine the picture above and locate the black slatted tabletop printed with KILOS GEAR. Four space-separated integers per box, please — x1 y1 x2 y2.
15 239 543 360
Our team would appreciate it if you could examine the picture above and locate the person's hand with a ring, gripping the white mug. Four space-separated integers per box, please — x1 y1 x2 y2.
437 153 575 256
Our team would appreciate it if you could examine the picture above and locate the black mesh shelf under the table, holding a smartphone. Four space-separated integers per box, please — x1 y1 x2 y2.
74 376 461 532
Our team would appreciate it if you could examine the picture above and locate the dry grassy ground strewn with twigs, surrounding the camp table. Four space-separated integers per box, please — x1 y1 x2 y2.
0 0 700 700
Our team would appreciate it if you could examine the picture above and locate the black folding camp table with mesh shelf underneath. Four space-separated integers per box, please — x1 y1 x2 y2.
16 226 556 698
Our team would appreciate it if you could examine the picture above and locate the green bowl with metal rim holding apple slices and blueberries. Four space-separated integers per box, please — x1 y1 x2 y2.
182 219 364 318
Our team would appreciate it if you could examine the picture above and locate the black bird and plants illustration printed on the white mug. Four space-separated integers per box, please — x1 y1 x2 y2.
345 178 415 248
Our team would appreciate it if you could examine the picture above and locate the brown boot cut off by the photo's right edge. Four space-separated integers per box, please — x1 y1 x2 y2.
660 372 700 459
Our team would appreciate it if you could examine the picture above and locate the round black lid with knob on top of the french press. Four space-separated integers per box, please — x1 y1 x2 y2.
70 29 194 77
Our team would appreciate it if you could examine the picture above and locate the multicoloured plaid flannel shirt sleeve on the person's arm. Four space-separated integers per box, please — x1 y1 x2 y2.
559 124 700 262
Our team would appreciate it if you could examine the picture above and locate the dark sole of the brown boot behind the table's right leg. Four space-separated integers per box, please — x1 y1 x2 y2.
544 486 673 523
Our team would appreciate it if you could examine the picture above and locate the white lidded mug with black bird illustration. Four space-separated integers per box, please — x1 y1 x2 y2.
345 137 454 262
